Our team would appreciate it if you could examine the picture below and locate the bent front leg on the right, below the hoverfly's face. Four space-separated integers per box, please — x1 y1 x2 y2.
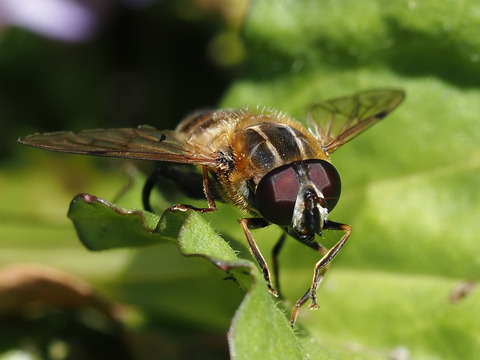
290 221 352 325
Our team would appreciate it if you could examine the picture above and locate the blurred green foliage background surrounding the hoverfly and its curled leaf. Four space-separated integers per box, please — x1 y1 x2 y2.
0 0 480 359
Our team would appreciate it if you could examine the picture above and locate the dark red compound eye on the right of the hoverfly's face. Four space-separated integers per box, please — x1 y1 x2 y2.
306 160 342 212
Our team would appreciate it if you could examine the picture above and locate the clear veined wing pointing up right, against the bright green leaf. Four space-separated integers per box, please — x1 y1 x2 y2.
307 89 405 154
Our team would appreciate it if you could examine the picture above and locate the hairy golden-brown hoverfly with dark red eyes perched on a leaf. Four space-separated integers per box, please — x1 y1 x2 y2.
19 89 404 325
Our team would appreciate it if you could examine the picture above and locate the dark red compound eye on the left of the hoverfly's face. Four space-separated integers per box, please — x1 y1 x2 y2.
255 164 300 225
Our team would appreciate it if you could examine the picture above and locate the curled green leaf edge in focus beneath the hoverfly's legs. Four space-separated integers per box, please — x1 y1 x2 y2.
69 194 302 359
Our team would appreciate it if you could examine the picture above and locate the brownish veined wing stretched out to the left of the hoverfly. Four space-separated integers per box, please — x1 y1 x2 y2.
19 125 218 167
